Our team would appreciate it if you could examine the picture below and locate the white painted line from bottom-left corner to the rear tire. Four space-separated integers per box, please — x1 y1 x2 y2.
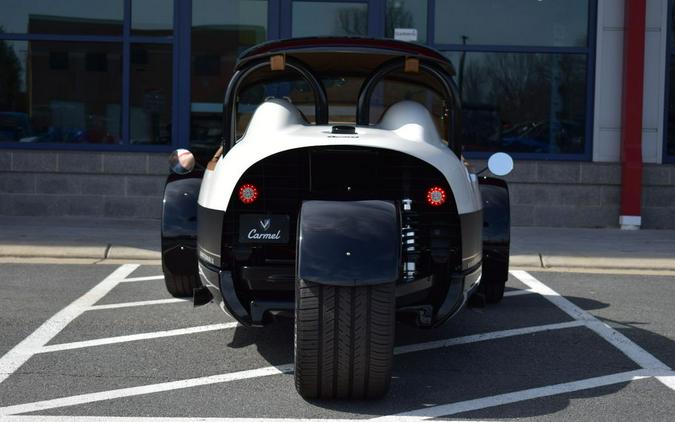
0 365 293 417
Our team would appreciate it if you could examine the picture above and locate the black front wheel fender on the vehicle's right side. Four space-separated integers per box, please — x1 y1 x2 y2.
479 177 511 281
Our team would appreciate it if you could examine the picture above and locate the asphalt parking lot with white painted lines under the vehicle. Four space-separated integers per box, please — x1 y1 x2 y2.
0 264 675 421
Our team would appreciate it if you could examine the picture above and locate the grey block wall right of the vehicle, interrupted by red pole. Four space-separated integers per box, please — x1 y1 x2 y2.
506 161 675 229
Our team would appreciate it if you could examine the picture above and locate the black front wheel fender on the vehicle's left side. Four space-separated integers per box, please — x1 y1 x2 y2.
161 171 203 276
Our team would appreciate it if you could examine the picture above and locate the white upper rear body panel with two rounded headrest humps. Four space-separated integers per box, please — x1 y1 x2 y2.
199 100 482 214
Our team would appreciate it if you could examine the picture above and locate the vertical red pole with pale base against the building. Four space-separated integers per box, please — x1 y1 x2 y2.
619 0 646 230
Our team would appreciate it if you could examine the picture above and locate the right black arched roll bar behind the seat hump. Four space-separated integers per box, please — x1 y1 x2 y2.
356 57 462 157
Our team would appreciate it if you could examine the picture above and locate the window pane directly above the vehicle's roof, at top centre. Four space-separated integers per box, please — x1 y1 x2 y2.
292 1 368 37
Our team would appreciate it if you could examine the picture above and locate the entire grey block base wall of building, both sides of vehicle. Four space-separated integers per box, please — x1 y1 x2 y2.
0 150 675 229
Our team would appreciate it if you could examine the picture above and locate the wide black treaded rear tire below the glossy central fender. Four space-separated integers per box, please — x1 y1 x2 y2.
295 280 395 399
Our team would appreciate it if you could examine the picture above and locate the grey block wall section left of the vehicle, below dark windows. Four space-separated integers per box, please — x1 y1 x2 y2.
0 151 168 218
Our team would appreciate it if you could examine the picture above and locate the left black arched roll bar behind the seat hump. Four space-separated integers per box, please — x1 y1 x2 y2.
222 56 328 151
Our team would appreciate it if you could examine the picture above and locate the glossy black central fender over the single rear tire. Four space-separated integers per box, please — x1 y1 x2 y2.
296 201 401 286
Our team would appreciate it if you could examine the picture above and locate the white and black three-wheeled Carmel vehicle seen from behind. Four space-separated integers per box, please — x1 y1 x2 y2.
162 38 513 398
